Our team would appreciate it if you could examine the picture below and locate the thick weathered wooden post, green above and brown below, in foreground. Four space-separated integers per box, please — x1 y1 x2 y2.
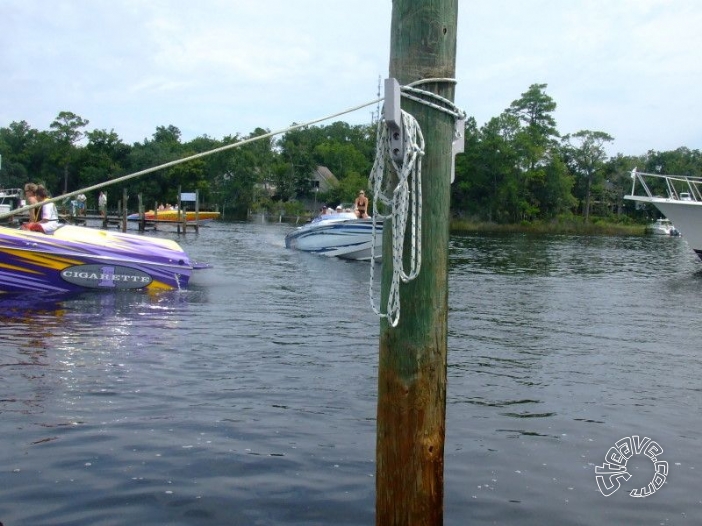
376 0 458 526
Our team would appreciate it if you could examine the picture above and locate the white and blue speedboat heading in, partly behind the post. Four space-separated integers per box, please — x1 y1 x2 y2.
285 212 383 260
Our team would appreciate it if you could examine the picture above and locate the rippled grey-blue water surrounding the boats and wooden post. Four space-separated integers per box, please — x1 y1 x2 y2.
0 224 702 526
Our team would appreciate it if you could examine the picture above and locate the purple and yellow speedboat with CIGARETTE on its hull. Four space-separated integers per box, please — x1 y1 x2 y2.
0 225 207 293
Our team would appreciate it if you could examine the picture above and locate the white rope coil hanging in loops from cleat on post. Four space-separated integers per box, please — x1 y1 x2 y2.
368 111 424 327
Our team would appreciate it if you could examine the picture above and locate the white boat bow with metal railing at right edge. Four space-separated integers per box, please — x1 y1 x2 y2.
624 168 702 259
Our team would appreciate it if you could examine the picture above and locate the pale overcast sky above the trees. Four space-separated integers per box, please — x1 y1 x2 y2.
0 0 702 155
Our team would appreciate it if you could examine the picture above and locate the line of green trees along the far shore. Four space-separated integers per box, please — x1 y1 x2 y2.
0 84 702 223
